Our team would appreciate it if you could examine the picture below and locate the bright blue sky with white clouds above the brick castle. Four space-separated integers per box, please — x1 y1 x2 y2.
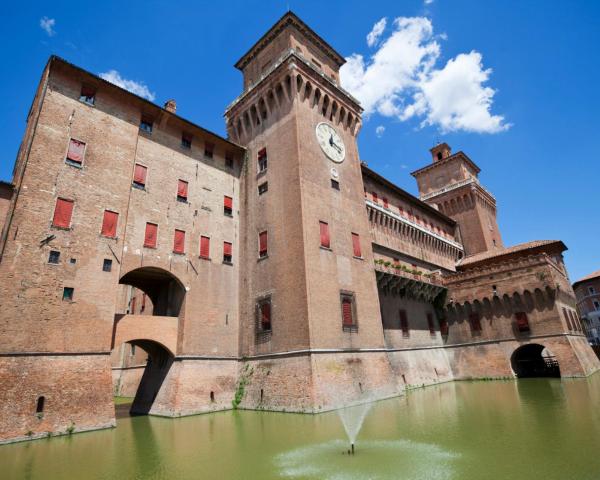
0 0 600 281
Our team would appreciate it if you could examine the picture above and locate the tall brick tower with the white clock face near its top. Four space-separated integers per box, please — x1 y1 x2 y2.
225 12 395 411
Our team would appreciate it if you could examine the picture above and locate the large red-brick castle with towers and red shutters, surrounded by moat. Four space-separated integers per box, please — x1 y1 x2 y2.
0 12 600 442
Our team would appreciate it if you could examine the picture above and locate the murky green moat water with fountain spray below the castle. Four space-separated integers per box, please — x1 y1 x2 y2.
0 374 600 480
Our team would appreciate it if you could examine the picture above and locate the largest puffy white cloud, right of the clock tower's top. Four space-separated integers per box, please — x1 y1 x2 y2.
340 17 510 133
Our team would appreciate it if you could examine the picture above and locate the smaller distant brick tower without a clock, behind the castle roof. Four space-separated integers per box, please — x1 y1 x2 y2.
411 143 503 255
